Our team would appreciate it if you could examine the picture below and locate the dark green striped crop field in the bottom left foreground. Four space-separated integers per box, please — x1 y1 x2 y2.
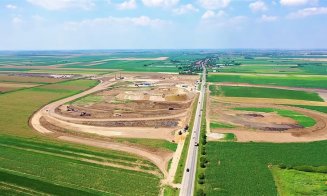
0 136 160 195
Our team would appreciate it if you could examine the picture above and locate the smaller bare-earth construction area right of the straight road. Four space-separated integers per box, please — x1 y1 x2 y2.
207 83 327 143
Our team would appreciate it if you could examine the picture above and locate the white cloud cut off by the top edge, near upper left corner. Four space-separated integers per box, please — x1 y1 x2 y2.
27 0 95 10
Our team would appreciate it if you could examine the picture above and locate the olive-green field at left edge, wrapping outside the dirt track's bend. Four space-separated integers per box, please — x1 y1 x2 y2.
0 80 96 136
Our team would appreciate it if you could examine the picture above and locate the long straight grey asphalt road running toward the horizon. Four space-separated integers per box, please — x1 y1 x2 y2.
179 66 206 196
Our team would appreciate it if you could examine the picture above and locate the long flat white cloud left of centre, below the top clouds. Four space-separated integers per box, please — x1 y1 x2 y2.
65 16 169 29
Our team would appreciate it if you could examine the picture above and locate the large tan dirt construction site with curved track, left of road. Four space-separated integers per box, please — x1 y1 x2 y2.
30 73 199 175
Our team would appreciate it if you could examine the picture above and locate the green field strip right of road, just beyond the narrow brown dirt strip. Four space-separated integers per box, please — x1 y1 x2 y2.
208 74 327 89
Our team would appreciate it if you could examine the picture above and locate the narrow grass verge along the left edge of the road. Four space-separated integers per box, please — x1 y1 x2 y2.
174 97 199 183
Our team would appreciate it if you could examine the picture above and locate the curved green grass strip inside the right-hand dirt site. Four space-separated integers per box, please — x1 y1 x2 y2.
234 108 316 127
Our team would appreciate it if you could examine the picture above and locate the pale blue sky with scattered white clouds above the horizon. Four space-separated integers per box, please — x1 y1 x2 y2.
0 0 327 50
